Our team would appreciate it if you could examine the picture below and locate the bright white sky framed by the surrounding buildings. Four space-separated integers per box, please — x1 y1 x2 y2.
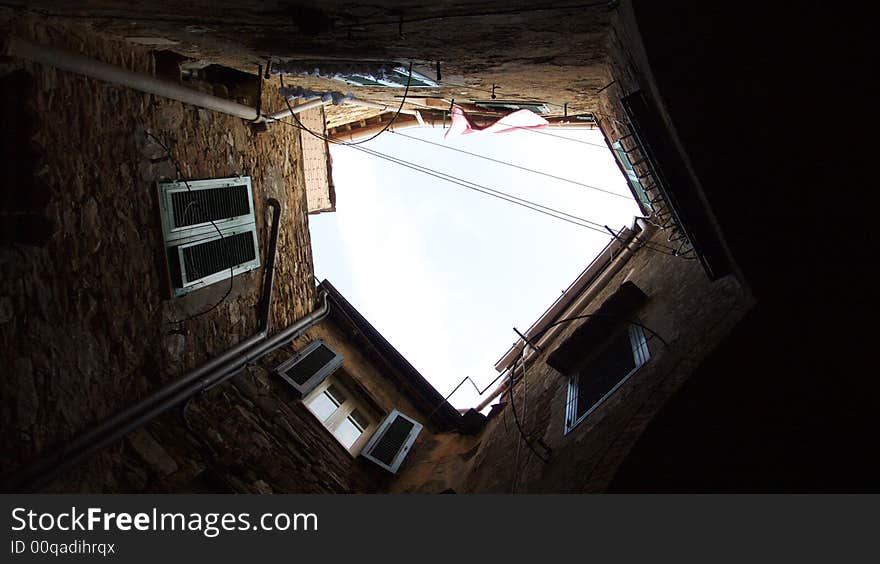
309 123 638 407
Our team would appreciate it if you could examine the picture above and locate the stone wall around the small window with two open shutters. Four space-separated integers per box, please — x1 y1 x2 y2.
116 308 458 493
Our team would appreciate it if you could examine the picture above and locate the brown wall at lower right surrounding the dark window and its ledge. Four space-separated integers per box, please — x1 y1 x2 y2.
396 226 752 493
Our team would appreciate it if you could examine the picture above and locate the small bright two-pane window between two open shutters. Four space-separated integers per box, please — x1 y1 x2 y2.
303 376 375 455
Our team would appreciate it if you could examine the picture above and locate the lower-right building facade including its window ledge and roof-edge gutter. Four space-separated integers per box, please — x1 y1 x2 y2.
393 225 753 493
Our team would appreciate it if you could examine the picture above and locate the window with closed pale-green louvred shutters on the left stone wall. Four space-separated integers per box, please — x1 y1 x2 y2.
158 176 260 297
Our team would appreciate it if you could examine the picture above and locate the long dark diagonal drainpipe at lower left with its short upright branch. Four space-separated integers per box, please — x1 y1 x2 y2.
2 200 330 491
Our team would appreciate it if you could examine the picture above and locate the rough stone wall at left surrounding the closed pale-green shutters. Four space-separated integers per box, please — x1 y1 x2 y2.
0 11 315 491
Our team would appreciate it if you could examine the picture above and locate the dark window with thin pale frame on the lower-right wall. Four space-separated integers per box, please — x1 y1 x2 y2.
565 325 650 433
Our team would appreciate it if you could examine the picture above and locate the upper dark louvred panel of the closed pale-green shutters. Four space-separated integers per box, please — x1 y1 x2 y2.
171 184 251 228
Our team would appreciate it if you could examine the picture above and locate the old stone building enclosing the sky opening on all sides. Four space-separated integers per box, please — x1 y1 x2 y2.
0 1 878 492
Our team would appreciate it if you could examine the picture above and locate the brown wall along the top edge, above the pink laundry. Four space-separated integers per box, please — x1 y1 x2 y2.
1 0 613 124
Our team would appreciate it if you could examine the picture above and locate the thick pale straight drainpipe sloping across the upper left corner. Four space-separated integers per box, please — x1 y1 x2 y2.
0 36 260 121
